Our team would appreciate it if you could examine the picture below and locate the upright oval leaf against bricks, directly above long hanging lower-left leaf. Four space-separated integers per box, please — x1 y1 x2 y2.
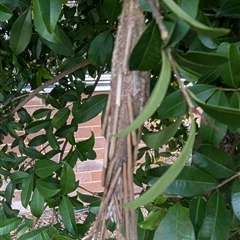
60 162 76 195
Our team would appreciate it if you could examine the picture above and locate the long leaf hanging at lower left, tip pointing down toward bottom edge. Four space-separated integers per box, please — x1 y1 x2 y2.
59 196 76 235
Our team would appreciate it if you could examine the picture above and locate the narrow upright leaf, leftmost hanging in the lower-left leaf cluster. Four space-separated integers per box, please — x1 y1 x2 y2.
21 174 34 208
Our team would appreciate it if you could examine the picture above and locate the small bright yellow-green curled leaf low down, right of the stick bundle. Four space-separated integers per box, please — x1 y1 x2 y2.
138 209 165 230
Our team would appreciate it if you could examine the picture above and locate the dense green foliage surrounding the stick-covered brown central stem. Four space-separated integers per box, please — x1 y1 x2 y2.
0 0 240 240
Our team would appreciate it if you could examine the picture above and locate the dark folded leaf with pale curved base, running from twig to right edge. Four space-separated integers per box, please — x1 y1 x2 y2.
189 91 240 128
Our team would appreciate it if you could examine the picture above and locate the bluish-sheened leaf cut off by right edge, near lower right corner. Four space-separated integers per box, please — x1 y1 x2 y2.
231 178 240 220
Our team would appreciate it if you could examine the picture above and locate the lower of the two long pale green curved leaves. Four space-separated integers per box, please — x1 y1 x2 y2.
124 123 196 207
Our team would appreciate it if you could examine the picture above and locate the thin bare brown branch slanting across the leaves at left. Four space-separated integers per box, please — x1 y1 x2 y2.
3 59 90 120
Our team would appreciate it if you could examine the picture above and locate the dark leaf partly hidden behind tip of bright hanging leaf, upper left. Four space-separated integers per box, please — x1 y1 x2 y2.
40 26 74 57
